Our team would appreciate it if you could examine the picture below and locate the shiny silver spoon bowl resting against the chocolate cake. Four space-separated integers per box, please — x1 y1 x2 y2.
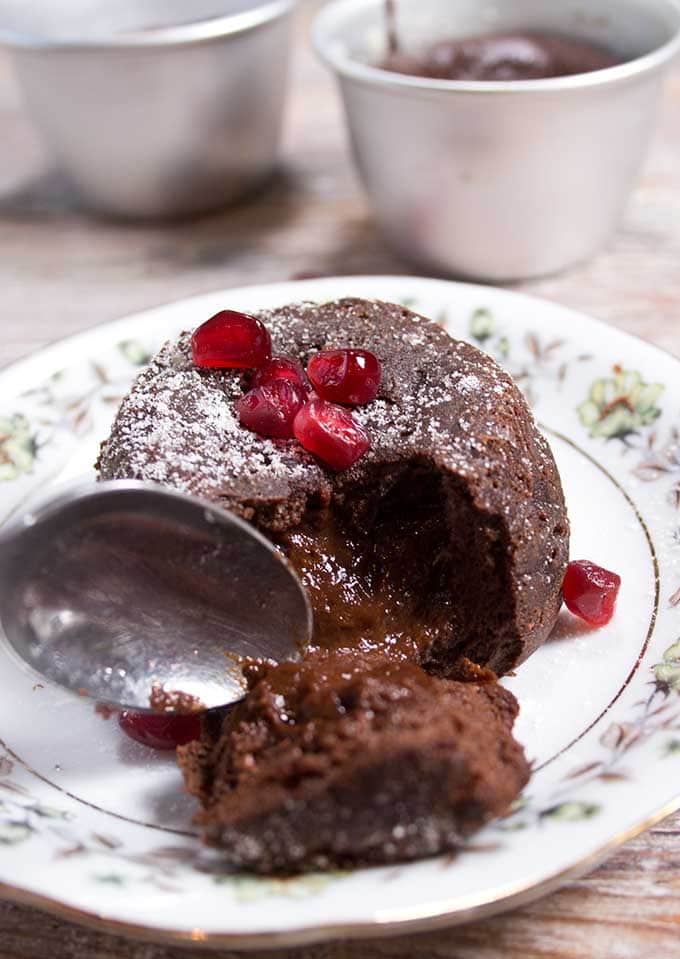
0 480 312 710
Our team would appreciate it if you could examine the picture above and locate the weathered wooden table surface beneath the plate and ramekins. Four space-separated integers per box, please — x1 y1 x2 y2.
0 0 680 959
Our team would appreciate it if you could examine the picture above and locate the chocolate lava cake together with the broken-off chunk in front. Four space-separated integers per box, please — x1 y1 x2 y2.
98 299 569 873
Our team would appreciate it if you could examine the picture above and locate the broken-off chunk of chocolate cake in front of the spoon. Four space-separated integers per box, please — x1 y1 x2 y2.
178 653 529 873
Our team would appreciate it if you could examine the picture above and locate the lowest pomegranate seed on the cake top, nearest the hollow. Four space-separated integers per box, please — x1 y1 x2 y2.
293 399 371 470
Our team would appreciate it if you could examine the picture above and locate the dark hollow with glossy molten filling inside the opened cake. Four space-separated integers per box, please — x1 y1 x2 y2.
278 461 517 675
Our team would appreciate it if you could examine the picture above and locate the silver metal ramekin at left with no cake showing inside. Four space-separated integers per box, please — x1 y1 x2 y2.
0 0 294 217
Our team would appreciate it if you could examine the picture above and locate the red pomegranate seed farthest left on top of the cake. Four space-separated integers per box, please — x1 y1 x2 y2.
191 310 272 369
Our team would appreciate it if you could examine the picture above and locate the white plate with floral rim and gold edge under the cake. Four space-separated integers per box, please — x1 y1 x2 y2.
0 277 680 947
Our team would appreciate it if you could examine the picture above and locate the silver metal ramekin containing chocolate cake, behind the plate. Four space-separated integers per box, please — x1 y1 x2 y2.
313 0 680 281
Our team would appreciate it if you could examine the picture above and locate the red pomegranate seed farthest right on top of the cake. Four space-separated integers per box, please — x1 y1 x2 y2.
307 350 381 406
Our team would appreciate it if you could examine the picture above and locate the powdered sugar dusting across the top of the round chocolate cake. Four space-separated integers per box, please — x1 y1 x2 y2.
100 299 554 564
